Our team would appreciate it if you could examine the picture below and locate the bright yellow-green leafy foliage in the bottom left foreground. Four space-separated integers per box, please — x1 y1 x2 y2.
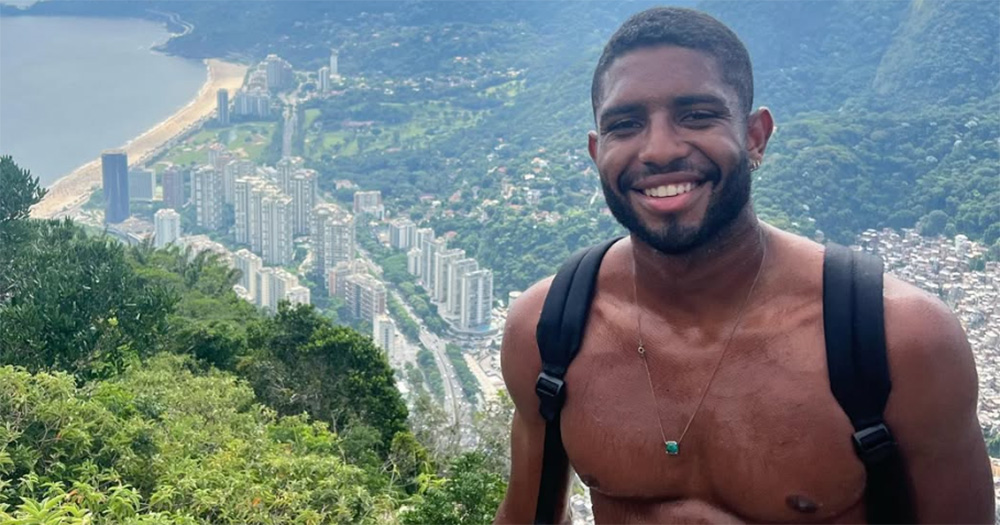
0 354 394 523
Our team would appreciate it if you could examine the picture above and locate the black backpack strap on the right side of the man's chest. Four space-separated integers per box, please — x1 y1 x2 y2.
823 244 915 523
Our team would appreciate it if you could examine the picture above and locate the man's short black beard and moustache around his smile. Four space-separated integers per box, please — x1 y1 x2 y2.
601 152 751 255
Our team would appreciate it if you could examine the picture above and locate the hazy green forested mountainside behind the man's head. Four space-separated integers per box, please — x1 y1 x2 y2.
5 0 1000 293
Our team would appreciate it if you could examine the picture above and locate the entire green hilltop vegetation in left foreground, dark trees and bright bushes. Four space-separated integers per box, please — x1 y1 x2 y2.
0 157 504 524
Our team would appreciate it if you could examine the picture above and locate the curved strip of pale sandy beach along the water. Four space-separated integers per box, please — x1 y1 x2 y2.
31 59 247 219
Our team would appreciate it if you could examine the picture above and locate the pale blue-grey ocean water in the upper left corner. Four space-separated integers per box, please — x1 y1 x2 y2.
0 17 206 186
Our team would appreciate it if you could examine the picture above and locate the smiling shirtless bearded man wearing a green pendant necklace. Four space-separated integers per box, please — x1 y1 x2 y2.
496 8 994 523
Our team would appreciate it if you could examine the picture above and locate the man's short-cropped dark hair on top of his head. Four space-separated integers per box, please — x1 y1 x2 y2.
590 7 753 118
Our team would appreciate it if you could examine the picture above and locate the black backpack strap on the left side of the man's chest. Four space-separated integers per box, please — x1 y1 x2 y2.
535 239 618 523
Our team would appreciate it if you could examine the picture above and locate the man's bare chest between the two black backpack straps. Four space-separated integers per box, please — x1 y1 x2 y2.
562 300 864 522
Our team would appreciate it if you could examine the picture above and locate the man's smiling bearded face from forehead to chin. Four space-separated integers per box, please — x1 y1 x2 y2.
589 46 750 254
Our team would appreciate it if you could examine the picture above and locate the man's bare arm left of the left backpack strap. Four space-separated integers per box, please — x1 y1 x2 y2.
496 279 569 523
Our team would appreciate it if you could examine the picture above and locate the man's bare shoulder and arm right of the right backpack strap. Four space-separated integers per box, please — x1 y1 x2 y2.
885 278 994 523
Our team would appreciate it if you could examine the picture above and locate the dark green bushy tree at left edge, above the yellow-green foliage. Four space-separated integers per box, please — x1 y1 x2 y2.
0 220 177 380
